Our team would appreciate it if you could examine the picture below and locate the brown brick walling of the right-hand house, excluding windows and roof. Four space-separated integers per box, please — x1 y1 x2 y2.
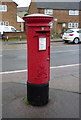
28 2 81 34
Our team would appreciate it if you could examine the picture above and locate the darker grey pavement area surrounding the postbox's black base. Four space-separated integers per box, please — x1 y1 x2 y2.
2 83 79 118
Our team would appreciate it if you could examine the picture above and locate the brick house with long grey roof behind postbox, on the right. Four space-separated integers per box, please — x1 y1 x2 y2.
28 2 81 34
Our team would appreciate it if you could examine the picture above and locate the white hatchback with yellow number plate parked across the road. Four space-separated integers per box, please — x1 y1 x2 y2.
62 28 81 44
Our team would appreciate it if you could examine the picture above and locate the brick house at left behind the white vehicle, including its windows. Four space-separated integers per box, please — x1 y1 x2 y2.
0 0 21 30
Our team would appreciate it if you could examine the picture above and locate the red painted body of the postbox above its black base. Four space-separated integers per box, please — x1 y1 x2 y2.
23 15 52 84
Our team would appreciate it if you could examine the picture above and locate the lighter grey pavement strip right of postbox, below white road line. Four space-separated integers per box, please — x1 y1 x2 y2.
50 65 81 93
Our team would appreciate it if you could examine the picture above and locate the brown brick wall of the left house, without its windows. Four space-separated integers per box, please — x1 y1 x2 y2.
0 2 20 30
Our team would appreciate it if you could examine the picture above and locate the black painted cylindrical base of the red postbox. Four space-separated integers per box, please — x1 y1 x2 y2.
27 82 49 106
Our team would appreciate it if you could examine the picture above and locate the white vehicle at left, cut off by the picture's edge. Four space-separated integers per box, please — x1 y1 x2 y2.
0 25 16 35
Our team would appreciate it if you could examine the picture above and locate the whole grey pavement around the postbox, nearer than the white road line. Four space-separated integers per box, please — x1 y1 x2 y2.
2 66 80 118
